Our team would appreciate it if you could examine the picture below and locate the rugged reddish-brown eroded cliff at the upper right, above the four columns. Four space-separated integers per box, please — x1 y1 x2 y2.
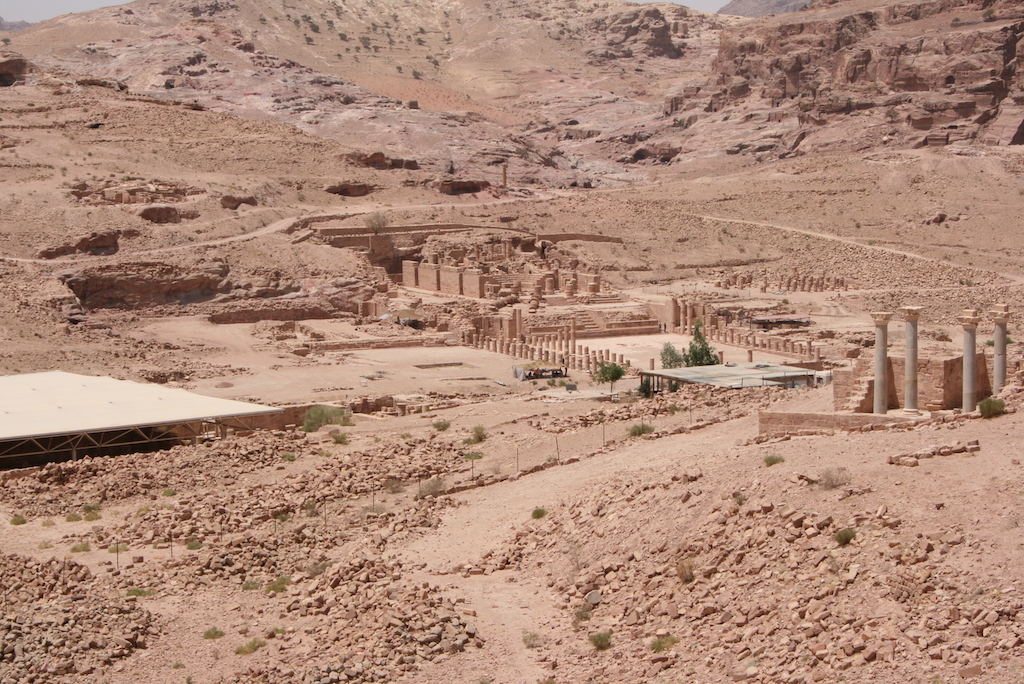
666 0 1024 152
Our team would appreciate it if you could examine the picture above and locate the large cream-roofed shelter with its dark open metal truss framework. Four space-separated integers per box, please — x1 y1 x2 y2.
0 371 282 467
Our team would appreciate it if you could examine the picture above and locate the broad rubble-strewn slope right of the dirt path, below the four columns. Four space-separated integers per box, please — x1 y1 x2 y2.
479 473 1024 684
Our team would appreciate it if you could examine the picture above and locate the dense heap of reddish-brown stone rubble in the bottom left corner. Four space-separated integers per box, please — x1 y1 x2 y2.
0 554 160 684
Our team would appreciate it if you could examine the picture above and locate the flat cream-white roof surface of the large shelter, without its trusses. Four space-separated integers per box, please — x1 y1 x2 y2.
0 371 281 439
